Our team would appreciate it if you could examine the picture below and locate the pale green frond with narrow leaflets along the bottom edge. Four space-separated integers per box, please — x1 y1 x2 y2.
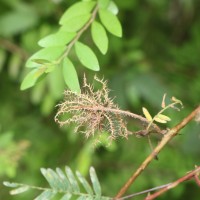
3 166 111 200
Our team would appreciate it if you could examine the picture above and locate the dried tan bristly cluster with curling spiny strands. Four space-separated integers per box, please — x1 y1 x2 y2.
55 77 133 140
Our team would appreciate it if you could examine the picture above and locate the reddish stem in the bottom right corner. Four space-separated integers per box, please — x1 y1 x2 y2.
145 166 200 200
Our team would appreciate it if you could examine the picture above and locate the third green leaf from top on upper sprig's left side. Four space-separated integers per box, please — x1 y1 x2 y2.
38 30 76 47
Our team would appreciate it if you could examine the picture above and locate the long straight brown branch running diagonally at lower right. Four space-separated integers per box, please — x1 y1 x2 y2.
114 106 200 199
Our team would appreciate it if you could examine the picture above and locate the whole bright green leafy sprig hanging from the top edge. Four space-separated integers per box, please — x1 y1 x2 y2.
21 0 122 92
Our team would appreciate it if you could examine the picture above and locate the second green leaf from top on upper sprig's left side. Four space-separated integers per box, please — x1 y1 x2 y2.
60 14 91 32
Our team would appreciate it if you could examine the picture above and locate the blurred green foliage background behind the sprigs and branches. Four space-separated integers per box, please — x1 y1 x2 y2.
0 0 200 200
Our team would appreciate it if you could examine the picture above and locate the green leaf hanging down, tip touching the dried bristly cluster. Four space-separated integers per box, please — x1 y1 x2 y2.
63 58 81 93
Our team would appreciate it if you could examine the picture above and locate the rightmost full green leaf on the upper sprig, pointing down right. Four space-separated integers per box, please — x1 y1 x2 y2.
99 9 122 37
